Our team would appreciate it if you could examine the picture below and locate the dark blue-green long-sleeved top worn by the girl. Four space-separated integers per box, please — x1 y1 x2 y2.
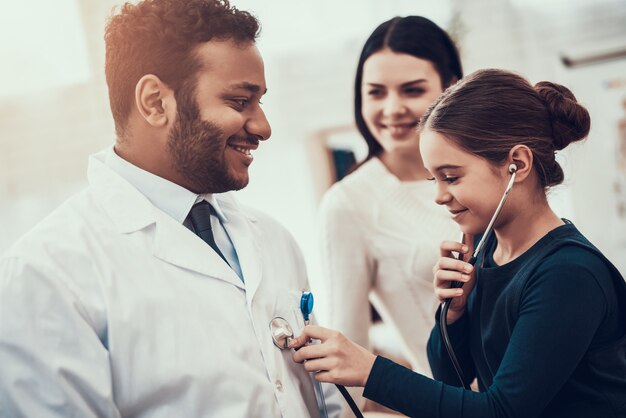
364 224 626 418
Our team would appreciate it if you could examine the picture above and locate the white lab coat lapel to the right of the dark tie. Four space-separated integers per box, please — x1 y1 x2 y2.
218 193 263 302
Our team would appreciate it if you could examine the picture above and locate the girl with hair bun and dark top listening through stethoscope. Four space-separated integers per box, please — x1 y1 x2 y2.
293 70 626 418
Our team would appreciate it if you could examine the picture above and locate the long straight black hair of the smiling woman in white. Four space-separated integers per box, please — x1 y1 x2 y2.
354 16 463 161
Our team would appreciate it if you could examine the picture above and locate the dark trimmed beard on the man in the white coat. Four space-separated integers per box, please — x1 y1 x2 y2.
167 94 252 194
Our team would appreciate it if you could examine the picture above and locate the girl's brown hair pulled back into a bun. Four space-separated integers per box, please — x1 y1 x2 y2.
418 69 591 188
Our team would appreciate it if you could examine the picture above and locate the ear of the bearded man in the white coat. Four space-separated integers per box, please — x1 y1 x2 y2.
135 74 176 128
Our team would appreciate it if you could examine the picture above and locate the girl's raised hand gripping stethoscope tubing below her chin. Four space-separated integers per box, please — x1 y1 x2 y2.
433 235 476 325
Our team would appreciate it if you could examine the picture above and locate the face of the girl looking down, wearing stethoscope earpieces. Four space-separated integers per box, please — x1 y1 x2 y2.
420 128 510 235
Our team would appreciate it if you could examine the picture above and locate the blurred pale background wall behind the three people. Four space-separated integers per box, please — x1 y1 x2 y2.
0 0 626 280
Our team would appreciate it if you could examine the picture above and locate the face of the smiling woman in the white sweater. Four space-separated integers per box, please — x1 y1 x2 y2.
361 49 442 157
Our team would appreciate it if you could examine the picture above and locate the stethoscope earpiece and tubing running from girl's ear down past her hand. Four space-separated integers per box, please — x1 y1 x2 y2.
439 164 517 390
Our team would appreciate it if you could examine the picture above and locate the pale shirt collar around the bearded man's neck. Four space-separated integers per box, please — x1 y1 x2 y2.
104 147 228 224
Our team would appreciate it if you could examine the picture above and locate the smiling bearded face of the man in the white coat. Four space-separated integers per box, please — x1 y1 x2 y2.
167 40 271 193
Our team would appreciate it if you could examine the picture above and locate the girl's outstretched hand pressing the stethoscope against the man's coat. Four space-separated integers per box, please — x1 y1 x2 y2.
289 325 376 386
